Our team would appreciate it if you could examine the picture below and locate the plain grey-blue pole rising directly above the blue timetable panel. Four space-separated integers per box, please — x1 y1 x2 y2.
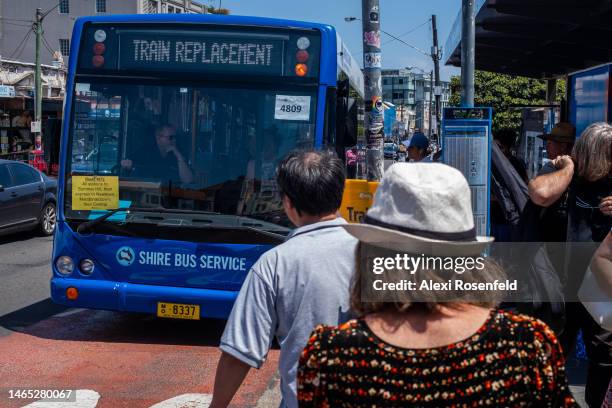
461 0 476 108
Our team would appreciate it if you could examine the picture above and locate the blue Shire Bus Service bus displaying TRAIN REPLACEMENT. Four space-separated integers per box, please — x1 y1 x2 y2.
51 14 363 319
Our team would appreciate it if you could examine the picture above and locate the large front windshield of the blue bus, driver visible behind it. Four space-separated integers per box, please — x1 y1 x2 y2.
64 78 316 232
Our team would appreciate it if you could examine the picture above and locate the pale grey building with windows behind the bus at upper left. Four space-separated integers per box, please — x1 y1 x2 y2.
0 0 206 65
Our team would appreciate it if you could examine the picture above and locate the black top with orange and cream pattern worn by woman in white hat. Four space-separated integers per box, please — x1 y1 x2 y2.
298 310 578 408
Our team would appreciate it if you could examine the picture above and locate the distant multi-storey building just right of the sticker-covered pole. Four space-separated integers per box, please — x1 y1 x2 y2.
382 68 450 134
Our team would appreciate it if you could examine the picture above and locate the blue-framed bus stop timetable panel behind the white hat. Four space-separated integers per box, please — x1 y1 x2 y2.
441 108 491 235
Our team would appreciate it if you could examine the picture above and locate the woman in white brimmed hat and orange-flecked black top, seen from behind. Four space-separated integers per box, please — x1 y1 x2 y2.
298 163 577 407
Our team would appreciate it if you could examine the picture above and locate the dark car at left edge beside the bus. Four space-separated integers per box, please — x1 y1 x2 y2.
0 160 57 235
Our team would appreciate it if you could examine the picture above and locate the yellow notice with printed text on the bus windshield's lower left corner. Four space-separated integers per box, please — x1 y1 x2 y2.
72 176 119 210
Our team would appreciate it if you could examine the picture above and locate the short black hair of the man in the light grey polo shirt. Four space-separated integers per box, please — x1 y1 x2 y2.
276 150 345 215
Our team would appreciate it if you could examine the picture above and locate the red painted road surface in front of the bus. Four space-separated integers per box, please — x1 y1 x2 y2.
0 311 278 408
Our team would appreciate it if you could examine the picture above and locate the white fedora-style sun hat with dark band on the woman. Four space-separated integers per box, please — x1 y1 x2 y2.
344 163 493 256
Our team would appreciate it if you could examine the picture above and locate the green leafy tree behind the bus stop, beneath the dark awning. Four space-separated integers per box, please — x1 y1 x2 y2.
449 71 565 133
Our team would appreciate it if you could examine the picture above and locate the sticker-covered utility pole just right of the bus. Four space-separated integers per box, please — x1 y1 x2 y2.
361 0 385 181
